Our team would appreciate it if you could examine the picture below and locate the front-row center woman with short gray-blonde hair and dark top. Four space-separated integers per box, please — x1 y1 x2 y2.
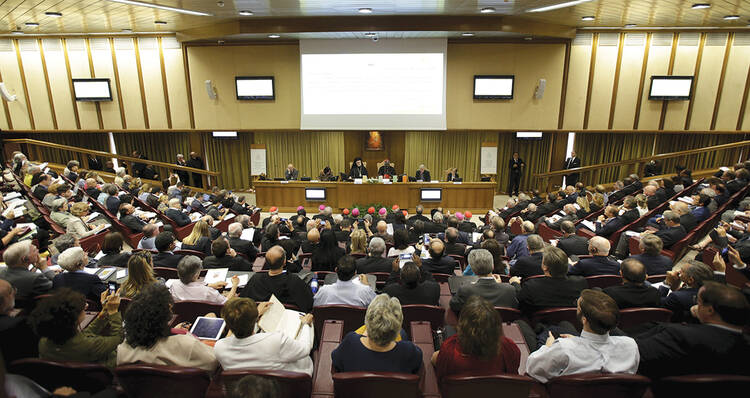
331 294 422 374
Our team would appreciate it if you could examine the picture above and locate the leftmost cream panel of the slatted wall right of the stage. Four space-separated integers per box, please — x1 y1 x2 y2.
562 33 594 130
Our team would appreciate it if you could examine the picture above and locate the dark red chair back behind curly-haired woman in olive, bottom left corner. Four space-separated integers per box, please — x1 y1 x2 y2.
8 358 113 393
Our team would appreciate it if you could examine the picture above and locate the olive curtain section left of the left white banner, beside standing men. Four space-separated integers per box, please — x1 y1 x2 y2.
203 132 253 189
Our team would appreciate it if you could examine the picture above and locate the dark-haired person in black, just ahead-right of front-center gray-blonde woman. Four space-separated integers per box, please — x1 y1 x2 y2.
383 260 440 305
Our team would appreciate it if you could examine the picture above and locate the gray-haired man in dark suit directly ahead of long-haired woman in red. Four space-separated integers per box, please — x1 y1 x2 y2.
450 249 521 313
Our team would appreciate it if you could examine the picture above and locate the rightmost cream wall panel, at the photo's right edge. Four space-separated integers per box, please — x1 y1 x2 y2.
715 34 750 130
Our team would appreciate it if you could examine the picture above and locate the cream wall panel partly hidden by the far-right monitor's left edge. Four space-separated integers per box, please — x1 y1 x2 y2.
638 33 674 130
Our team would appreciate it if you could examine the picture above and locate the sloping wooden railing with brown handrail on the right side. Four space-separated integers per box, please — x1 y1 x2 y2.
534 140 750 187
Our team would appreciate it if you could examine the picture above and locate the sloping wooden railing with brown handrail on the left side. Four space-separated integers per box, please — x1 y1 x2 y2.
3 138 220 188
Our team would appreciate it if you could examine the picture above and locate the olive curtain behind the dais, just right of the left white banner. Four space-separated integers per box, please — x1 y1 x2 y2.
253 131 346 179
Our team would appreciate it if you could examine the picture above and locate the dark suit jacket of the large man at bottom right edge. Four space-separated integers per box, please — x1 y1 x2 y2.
635 323 750 379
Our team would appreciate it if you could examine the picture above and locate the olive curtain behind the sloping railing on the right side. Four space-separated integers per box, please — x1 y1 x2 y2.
566 133 658 185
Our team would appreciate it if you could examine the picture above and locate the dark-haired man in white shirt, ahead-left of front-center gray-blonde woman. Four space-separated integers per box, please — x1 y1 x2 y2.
313 256 375 307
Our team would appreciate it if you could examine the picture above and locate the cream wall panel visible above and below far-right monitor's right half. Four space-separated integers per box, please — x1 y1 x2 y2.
660 32 701 130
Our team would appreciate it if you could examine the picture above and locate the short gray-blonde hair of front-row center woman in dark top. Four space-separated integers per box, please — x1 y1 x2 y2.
365 294 404 346
